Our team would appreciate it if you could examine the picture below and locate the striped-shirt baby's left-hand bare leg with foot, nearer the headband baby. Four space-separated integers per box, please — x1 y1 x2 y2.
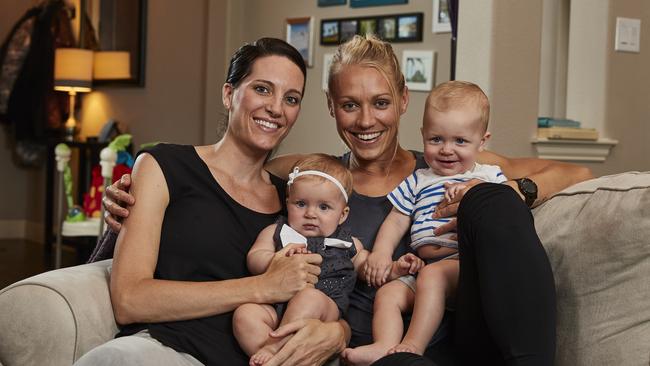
343 281 415 365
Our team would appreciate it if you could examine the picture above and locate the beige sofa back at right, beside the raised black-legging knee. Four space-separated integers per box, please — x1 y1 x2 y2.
533 172 650 365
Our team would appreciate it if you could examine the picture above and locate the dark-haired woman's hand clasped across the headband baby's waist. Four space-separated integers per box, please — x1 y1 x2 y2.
260 244 323 303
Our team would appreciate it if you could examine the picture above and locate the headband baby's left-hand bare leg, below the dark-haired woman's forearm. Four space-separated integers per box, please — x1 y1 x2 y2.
232 304 278 356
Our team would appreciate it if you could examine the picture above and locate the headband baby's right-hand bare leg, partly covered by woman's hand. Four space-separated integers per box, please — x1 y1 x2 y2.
250 288 339 365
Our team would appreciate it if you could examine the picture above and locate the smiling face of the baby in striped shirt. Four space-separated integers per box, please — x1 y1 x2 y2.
421 107 490 176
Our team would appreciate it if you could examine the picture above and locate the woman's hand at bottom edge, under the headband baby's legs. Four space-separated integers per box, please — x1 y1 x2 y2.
264 319 346 366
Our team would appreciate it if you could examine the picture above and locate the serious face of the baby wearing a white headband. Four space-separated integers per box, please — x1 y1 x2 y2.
287 176 349 237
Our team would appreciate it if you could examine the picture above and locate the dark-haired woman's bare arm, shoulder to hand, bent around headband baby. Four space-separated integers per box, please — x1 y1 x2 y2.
110 154 321 324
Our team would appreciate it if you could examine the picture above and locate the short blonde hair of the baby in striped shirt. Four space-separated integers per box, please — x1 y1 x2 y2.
425 80 490 132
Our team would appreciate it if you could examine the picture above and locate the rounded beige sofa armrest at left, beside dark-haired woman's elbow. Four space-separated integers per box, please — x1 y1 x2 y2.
0 260 118 366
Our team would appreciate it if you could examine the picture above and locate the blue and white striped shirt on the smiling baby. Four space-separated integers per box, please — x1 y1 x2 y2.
387 163 507 249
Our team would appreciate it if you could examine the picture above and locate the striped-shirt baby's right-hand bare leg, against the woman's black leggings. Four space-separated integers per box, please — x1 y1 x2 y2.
389 259 458 355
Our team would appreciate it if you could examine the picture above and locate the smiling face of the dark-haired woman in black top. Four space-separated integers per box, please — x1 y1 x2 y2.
223 56 304 152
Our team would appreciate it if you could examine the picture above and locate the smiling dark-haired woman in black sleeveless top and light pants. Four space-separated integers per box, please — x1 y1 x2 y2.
77 38 345 365
